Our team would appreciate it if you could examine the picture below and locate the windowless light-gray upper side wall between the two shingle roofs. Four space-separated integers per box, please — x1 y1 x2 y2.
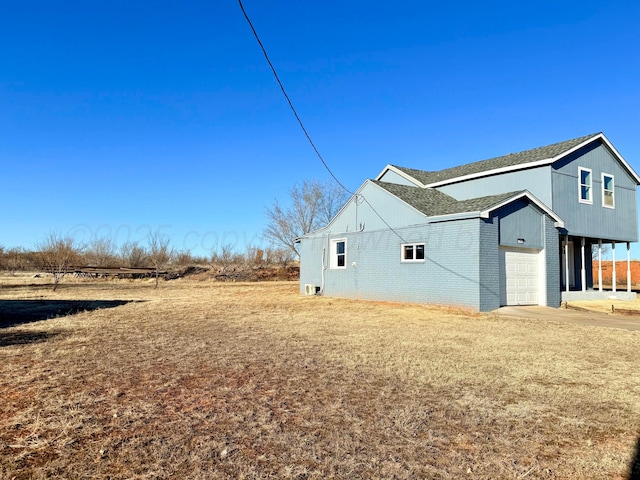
437 166 552 208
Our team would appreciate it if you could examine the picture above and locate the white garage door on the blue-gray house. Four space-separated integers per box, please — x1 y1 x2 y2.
500 248 540 305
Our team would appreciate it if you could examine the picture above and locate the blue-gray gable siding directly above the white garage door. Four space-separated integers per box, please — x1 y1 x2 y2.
495 200 546 249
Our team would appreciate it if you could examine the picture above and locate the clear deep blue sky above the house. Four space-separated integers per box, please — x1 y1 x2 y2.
0 0 640 258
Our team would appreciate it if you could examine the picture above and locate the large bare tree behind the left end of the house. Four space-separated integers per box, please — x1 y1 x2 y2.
264 180 347 256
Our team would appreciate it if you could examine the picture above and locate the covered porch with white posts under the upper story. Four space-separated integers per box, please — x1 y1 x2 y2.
560 235 636 301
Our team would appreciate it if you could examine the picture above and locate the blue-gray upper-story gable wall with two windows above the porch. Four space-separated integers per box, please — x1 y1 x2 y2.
551 144 638 242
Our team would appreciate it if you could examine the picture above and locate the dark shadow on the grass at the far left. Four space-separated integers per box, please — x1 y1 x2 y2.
0 300 132 328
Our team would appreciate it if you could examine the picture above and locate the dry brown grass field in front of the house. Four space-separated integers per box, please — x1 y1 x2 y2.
0 277 640 479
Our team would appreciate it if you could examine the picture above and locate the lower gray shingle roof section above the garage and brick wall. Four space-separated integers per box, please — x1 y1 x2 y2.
372 180 522 217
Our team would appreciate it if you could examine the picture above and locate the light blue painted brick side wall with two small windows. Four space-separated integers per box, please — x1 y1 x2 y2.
300 219 490 310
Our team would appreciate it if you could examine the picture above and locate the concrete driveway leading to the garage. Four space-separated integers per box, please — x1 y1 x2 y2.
493 306 640 331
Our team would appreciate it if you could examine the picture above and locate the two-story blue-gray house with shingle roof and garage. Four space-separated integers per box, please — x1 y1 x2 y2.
299 133 640 311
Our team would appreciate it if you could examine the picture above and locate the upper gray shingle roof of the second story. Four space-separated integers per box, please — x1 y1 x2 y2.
394 133 599 185
